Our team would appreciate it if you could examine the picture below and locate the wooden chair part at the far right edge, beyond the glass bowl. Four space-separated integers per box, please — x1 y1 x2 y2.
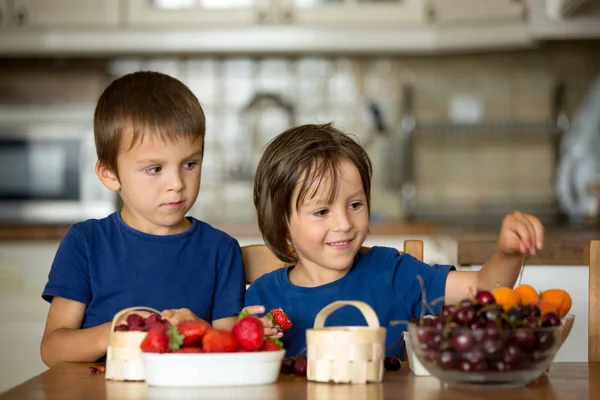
588 240 600 362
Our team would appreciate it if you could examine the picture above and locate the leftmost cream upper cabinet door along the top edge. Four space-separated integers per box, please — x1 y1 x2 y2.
7 0 119 28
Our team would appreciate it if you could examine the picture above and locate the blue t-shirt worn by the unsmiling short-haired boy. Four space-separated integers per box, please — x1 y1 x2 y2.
42 212 245 328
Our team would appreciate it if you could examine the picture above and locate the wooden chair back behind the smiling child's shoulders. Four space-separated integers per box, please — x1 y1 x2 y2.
242 240 423 284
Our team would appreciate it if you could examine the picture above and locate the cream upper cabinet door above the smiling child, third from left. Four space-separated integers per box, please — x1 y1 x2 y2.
279 0 427 28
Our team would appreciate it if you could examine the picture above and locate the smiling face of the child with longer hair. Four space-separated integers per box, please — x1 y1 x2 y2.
289 161 369 271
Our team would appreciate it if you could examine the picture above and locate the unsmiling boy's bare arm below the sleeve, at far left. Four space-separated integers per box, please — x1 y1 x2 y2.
40 297 111 367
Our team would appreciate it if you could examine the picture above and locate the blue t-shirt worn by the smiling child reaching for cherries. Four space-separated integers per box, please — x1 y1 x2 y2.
244 247 454 358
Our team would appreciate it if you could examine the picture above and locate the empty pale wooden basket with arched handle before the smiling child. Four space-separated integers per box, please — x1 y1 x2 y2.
306 301 386 384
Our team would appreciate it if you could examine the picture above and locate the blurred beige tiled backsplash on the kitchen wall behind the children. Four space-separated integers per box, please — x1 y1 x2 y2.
0 42 600 222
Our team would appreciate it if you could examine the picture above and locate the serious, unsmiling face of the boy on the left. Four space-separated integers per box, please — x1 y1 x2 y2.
106 136 202 235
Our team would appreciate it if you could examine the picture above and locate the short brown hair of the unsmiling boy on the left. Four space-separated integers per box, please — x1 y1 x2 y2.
94 71 206 176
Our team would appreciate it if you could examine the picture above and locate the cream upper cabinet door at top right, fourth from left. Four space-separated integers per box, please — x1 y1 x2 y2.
430 0 527 24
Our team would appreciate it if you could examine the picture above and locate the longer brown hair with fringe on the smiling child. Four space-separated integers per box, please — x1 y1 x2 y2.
254 124 372 263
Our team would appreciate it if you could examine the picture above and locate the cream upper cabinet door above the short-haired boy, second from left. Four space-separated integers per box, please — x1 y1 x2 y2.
125 0 276 28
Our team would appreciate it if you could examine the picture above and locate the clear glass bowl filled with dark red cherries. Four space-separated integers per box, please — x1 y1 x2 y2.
408 291 575 387
